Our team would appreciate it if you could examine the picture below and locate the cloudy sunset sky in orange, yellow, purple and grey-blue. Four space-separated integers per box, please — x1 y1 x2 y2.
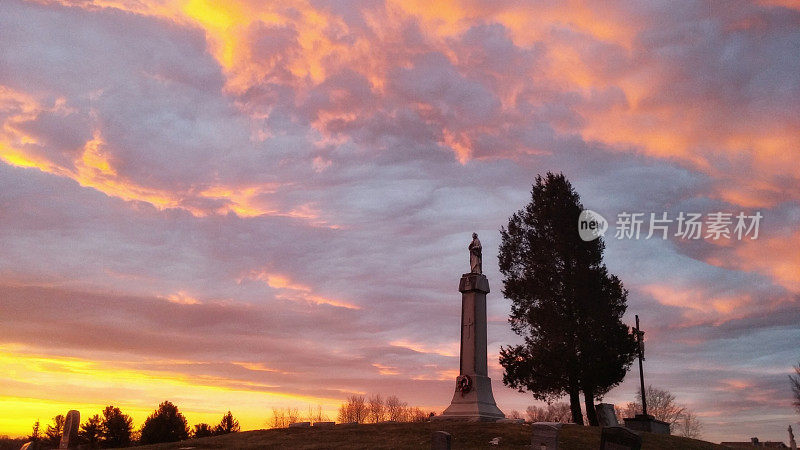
0 0 800 442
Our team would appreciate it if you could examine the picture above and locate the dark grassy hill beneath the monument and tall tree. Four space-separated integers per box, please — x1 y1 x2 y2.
137 422 725 450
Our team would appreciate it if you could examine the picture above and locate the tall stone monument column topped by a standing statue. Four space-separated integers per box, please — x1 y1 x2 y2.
437 233 505 421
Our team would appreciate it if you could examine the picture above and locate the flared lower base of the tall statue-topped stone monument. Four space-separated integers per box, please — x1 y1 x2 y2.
433 375 506 422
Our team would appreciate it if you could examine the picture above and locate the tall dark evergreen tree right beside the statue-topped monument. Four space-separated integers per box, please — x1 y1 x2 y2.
498 173 636 425
